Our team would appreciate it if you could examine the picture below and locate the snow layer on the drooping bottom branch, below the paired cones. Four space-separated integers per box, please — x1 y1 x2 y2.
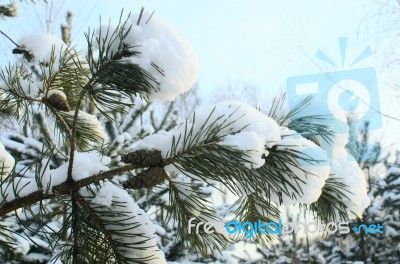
84 182 166 264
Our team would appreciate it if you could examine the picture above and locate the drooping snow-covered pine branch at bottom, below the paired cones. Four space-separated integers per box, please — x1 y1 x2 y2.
54 182 162 263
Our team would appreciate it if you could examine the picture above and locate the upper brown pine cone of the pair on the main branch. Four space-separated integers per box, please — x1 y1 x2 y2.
121 149 162 167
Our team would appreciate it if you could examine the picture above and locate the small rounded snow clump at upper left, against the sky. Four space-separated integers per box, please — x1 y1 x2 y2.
18 33 67 63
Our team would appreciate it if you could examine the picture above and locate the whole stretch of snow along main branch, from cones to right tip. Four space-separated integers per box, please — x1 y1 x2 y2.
131 99 369 214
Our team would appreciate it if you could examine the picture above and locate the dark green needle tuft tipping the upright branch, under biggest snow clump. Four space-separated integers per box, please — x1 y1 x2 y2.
86 14 162 119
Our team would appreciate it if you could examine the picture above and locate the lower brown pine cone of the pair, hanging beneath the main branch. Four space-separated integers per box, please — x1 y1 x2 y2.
122 166 167 190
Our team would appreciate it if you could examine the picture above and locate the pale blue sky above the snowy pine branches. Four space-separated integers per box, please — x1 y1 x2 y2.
0 0 400 152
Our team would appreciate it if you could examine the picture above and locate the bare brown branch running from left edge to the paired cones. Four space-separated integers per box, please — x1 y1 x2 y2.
0 164 138 216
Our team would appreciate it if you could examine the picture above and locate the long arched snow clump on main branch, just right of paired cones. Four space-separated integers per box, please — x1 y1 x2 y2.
132 102 281 168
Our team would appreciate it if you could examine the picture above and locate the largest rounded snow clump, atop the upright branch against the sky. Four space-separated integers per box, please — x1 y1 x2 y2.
94 12 199 101
